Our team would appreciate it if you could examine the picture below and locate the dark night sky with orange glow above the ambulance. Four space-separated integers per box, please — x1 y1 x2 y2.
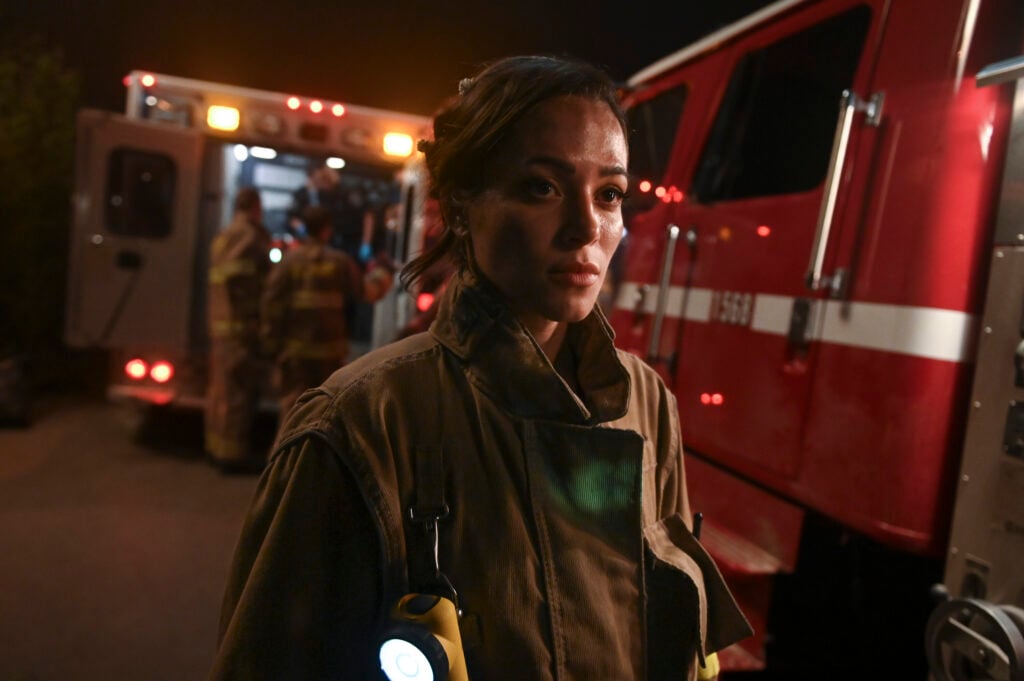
6 0 768 115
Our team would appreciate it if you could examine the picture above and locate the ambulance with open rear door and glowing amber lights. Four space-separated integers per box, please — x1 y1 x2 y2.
66 71 429 408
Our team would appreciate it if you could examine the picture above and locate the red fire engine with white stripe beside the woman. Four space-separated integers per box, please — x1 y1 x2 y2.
607 0 1024 679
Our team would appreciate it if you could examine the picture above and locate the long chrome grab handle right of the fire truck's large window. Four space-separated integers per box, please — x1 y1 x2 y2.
804 90 884 297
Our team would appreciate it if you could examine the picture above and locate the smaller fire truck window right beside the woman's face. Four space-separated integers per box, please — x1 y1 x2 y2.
626 85 687 191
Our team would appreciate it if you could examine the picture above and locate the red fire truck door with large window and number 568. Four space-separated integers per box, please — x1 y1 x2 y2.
620 2 885 479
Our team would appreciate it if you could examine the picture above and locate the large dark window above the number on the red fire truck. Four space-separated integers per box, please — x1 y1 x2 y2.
691 6 870 203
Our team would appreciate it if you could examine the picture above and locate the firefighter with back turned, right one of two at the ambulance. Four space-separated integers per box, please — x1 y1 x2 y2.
260 201 393 428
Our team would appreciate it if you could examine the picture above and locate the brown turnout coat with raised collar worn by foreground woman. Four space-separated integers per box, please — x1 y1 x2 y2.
211 274 750 681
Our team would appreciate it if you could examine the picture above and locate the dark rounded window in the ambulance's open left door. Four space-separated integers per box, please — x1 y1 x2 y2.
106 147 176 239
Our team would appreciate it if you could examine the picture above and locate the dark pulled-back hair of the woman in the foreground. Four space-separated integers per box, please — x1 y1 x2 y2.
401 56 626 289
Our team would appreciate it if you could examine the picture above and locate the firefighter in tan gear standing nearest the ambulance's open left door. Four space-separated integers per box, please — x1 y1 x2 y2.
205 187 270 472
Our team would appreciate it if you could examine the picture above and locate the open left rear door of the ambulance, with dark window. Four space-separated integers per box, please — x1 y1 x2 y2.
66 110 203 350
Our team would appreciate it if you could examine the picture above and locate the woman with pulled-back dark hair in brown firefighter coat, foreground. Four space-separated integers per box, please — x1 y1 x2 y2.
212 56 749 681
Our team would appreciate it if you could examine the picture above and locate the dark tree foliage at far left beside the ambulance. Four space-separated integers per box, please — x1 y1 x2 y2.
0 43 80 378
